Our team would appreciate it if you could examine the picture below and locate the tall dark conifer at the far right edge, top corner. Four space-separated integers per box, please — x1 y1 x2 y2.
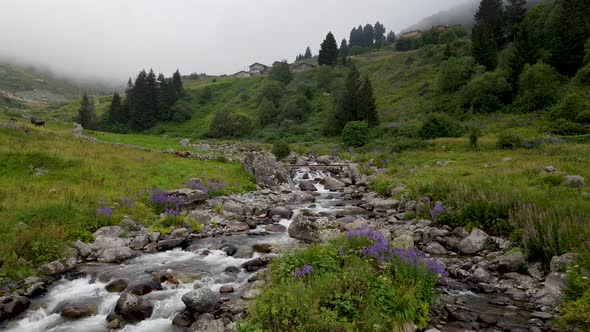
549 0 590 76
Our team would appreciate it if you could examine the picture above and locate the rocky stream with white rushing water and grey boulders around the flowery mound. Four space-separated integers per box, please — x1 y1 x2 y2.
0 153 573 331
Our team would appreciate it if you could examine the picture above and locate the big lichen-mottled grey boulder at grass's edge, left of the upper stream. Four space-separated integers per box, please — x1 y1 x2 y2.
244 152 292 189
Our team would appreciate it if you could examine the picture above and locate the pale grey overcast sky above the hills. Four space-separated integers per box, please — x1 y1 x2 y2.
0 0 469 80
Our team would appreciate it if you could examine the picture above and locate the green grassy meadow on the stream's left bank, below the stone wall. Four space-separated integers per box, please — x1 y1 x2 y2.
0 125 253 278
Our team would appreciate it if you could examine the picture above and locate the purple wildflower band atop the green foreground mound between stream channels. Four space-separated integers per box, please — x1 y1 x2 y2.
346 228 448 278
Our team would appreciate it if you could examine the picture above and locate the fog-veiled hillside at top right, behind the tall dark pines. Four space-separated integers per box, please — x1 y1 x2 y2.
403 0 554 31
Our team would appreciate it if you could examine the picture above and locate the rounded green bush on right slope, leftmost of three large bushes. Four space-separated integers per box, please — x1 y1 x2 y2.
437 56 482 93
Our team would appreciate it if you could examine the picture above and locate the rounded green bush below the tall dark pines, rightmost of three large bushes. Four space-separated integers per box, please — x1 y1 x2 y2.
514 62 561 112
